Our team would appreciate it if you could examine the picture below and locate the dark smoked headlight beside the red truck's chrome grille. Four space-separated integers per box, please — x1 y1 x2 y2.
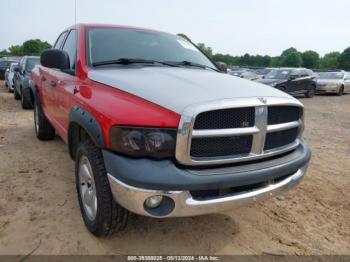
109 126 177 158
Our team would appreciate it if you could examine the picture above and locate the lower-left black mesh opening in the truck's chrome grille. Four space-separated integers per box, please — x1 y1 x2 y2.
191 135 253 158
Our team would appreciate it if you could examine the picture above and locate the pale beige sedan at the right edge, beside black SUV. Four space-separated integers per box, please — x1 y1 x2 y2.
316 71 350 96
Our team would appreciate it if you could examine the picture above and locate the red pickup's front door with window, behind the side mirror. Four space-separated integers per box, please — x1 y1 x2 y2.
50 29 78 138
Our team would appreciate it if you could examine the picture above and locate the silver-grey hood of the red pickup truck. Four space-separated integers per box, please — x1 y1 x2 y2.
88 66 292 114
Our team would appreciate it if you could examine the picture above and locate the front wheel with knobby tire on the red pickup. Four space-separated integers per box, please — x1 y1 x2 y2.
75 140 129 237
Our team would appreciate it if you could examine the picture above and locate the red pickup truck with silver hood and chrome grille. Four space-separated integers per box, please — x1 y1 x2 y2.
31 24 311 236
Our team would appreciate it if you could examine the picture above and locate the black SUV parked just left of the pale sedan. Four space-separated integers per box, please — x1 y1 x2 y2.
259 68 316 98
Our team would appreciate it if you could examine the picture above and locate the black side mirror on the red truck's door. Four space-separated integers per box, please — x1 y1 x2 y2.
40 49 70 70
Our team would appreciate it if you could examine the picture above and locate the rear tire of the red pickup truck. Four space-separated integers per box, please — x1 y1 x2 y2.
34 99 55 141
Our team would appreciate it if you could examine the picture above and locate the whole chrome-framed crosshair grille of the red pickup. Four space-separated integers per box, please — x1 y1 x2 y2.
176 98 303 165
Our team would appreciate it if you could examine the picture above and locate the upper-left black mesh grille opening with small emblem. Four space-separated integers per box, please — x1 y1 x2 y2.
194 107 255 130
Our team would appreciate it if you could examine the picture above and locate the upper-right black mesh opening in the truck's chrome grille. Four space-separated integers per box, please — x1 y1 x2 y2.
267 106 302 125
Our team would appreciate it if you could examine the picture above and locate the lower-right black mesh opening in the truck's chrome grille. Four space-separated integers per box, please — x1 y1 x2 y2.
264 127 299 150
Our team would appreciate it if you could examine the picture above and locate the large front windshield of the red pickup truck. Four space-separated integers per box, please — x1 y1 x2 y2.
87 28 216 69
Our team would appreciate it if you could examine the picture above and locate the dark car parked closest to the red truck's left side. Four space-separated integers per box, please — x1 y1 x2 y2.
13 56 40 109
